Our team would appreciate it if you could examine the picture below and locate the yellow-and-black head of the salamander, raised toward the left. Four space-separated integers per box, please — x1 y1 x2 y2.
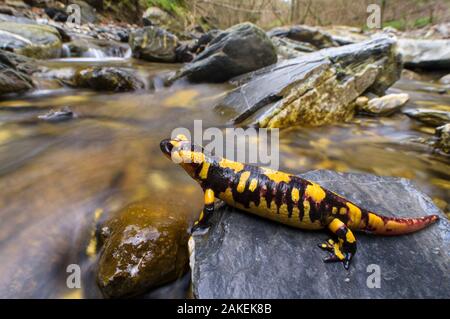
159 134 206 178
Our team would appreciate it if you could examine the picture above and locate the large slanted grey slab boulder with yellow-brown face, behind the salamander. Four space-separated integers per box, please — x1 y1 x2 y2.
217 37 401 128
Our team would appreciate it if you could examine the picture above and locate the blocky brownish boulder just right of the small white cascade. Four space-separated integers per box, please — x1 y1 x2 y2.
129 26 179 62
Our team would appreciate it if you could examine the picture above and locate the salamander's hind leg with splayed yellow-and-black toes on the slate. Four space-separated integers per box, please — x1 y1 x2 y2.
319 218 356 269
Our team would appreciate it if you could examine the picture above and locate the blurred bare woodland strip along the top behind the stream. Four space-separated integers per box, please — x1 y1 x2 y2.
182 0 450 28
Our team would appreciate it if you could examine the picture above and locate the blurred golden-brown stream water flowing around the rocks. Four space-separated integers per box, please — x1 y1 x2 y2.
0 56 450 298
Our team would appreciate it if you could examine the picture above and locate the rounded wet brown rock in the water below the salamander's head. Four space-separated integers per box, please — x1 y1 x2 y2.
97 201 189 298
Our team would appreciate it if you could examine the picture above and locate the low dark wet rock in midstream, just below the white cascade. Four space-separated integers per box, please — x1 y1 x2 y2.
69 67 145 92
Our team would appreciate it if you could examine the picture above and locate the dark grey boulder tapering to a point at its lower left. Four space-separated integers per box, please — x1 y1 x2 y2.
168 23 277 83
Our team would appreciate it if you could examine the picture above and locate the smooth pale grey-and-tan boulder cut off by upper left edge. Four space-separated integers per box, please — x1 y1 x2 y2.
0 22 62 59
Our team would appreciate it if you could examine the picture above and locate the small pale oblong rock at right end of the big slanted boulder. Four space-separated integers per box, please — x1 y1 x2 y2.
358 93 409 116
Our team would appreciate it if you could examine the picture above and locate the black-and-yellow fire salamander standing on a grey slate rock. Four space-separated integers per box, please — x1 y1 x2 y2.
160 135 439 269
